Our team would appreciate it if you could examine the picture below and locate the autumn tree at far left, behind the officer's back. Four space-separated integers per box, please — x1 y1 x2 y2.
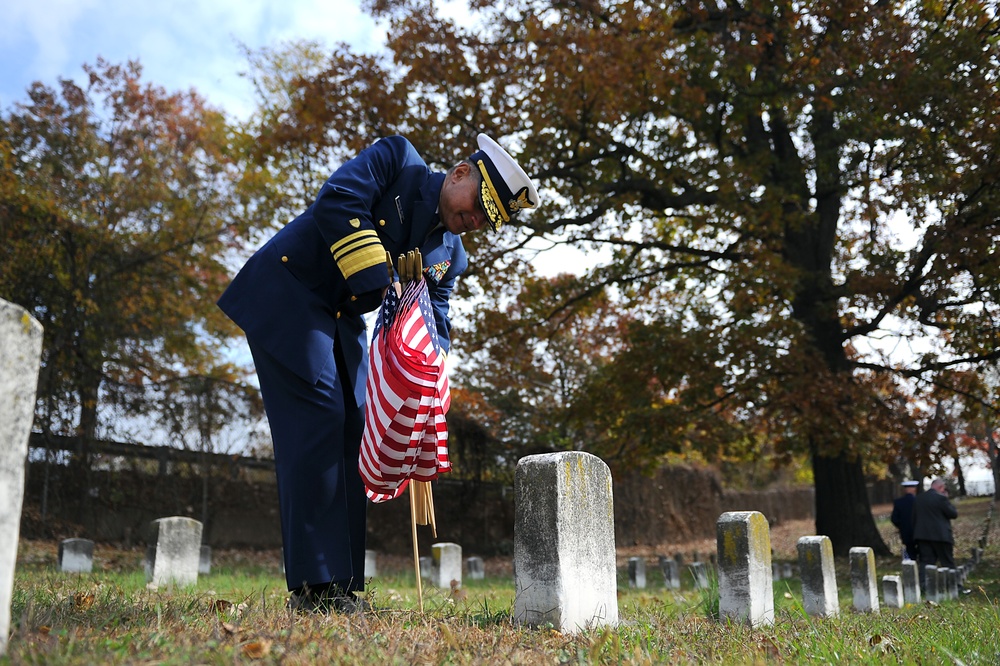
0 60 260 482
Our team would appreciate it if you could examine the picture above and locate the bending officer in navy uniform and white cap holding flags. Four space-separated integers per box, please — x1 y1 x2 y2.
219 134 539 612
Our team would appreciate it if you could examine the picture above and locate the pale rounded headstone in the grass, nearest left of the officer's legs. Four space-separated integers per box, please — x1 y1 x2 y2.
146 516 202 587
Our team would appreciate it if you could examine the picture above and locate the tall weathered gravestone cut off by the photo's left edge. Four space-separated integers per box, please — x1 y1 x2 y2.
0 299 42 655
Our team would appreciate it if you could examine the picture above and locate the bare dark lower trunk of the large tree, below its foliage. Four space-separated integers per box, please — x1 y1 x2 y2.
812 446 892 556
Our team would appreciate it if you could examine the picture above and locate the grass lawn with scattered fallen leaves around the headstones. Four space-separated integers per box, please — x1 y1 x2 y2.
0 499 1000 664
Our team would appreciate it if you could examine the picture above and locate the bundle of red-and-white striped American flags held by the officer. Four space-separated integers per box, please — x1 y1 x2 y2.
358 279 451 502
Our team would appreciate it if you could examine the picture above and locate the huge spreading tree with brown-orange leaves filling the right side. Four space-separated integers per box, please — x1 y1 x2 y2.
246 0 1000 553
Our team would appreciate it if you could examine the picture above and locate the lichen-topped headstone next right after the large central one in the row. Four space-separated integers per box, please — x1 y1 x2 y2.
715 511 774 627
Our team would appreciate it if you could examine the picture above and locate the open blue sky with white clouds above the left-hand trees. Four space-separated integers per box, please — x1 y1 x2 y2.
0 0 385 116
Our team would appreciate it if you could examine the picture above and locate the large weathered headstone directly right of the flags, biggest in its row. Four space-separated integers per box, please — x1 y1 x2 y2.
514 451 618 633
